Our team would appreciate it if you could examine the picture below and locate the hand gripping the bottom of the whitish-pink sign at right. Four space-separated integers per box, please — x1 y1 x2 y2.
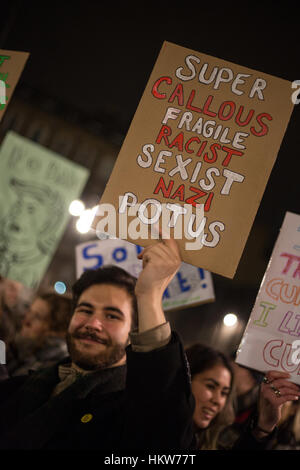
255 371 300 438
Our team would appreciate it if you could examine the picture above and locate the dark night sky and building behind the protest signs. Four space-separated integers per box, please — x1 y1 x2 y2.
0 0 300 352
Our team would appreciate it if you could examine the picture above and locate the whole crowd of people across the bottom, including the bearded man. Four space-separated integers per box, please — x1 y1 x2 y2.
0 239 300 451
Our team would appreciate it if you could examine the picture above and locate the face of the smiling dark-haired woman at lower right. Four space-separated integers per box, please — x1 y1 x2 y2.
192 364 231 429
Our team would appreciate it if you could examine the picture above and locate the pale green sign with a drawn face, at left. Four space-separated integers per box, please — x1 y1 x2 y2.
0 132 89 288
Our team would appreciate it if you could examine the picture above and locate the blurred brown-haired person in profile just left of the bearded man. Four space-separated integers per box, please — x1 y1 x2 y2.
7 293 72 376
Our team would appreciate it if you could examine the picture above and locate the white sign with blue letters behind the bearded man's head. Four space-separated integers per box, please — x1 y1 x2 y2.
76 239 215 311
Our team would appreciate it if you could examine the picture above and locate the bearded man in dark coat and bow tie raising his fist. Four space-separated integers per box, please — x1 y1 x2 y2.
0 239 194 451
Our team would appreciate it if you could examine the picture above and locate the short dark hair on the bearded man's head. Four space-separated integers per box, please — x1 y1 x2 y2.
72 265 138 331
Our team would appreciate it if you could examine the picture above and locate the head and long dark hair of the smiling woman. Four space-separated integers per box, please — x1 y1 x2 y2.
186 344 234 450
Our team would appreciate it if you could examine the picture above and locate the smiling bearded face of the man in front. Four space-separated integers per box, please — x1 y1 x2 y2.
67 284 132 370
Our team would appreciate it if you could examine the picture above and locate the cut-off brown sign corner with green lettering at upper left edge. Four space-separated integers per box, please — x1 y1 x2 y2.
0 49 29 121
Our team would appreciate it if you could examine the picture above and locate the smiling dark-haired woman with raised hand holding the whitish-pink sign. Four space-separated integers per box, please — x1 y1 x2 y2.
186 344 300 450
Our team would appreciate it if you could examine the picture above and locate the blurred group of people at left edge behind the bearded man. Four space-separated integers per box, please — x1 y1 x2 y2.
0 279 72 376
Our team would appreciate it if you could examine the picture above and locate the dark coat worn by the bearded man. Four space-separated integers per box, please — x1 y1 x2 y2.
0 333 194 451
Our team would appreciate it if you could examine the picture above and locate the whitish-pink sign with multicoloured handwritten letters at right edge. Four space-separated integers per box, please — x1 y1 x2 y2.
236 212 300 384
